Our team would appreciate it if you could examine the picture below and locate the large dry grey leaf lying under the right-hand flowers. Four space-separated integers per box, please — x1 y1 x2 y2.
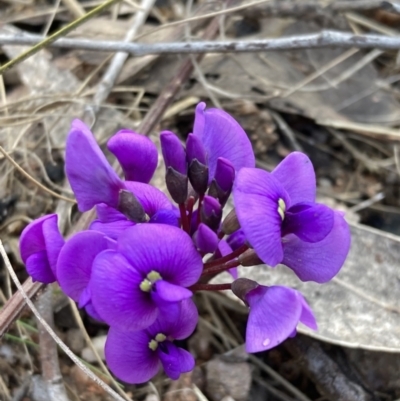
215 224 400 352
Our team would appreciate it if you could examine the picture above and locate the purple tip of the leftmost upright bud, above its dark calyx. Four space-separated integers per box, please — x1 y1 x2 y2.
160 131 187 175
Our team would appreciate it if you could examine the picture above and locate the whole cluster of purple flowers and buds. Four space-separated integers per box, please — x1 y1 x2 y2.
20 103 350 383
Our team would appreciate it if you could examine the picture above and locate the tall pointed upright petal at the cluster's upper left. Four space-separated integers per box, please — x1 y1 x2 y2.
65 120 124 212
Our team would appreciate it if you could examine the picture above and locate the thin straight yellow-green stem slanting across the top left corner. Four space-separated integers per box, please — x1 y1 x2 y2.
0 0 121 75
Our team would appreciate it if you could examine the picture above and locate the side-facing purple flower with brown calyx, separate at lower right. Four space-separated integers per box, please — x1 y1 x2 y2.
232 279 317 352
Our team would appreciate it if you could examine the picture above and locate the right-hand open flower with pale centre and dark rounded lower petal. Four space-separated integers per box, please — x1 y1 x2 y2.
233 152 342 271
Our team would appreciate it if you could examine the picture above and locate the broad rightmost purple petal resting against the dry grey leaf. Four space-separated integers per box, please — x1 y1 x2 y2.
282 212 350 283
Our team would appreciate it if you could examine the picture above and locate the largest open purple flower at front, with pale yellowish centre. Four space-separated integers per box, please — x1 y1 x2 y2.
90 224 203 331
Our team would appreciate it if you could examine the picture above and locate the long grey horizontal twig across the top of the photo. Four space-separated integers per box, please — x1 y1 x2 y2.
4 30 400 54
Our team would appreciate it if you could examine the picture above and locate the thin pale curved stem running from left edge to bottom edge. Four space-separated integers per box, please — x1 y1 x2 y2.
0 240 125 401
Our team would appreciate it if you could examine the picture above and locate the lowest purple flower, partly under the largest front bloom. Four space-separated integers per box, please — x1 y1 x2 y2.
105 299 198 383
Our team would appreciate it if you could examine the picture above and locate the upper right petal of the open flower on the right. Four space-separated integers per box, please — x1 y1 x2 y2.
271 152 317 205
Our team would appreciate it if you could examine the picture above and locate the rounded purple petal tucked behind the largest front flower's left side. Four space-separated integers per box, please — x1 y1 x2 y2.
57 231 109 302
